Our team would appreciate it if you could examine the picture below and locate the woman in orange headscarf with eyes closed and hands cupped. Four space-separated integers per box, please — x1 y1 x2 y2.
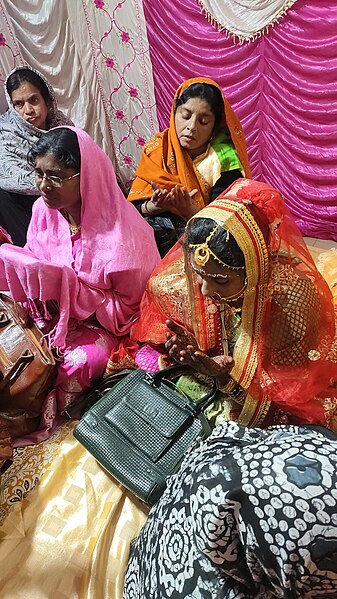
129 77 250 256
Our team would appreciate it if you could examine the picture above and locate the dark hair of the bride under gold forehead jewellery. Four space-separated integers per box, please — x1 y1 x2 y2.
183 218 245 267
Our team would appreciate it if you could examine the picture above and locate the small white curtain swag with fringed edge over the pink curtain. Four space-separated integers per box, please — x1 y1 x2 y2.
197 0 296 42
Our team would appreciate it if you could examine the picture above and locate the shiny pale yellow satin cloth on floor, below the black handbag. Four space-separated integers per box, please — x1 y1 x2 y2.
0 432 149 599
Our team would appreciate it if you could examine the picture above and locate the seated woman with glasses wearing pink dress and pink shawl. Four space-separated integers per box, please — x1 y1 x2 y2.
0 127 159 452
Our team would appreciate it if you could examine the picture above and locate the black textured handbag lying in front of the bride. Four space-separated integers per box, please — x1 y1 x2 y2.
74 365 217 505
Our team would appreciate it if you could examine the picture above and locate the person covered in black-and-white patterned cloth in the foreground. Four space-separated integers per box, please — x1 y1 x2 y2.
124 422 337 599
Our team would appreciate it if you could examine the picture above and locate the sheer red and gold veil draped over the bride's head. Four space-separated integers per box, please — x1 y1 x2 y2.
133 179 337 428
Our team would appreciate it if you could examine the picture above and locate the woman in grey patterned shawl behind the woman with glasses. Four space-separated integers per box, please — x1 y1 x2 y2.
0 66 72 246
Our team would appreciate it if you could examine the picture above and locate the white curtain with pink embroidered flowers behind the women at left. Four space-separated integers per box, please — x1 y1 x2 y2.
0 0 158 187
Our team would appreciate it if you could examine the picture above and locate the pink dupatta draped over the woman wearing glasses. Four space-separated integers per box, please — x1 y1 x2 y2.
0 127 159 348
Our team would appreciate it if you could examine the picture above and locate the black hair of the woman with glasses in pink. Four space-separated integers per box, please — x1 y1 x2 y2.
27 127 81 172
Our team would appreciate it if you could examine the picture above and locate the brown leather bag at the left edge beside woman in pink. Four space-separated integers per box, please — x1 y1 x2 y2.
0 293 56 437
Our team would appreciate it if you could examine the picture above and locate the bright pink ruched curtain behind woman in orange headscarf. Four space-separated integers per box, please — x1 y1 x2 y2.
144 0 337 240
